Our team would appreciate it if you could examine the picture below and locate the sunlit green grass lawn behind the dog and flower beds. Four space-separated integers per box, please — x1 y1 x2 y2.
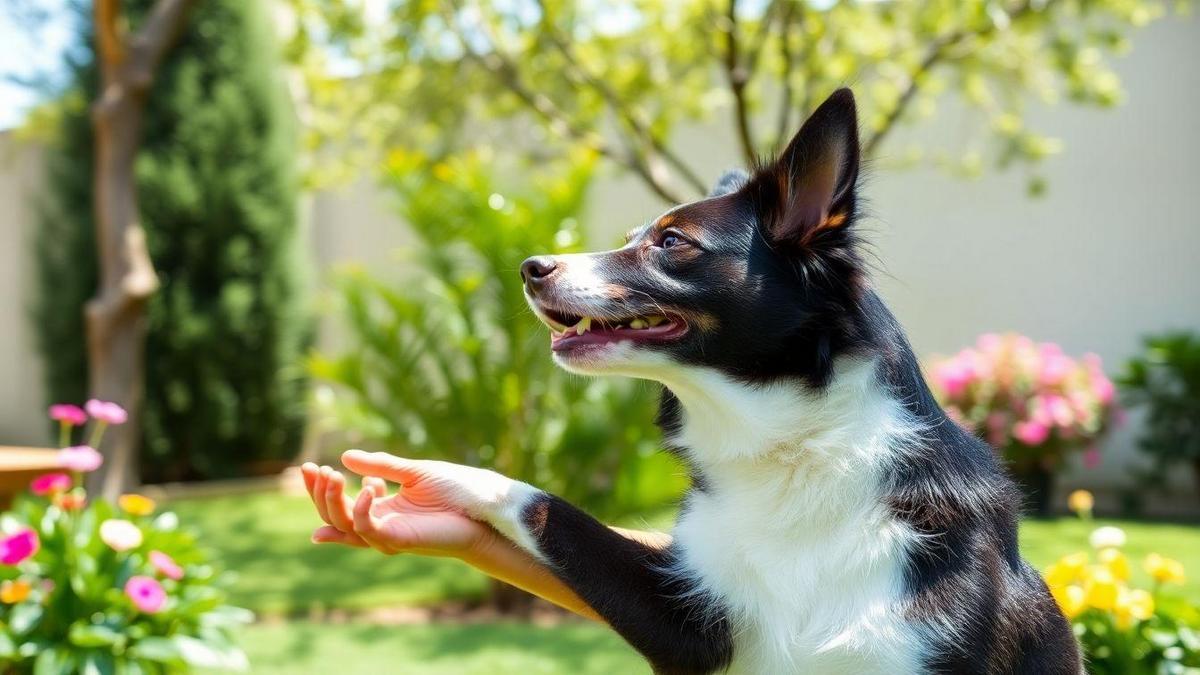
170 494 1200 675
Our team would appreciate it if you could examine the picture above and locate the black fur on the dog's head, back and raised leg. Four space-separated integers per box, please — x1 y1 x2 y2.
516 90 1081 674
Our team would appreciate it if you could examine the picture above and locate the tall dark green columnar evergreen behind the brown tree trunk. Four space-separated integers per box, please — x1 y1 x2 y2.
34 0 312 482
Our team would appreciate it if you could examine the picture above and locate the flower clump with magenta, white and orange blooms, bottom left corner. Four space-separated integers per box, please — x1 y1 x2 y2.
0 401 251 675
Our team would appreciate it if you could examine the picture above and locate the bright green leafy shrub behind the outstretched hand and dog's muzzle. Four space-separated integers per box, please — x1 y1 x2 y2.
311 155 683 518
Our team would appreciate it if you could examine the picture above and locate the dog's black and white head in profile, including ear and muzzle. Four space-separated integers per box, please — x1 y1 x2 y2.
521 89 863 383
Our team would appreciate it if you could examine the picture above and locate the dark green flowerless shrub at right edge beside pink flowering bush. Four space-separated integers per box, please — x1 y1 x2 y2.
1118 333 1200 485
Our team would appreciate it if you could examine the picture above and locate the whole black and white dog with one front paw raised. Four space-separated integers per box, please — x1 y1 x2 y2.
420 89 1081 675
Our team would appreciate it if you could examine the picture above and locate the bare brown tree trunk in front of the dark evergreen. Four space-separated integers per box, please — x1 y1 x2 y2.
85 0 192 498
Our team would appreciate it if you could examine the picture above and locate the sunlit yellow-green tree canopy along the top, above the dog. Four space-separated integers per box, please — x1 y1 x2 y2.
278 0 1188 203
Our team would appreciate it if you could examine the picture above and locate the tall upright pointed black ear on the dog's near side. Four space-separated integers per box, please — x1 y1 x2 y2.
755 89 859 245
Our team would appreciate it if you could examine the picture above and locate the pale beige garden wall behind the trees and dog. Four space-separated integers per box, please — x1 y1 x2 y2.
0 18 1200 504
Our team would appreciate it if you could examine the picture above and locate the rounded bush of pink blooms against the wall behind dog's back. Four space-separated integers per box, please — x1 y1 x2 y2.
930 334 1116 472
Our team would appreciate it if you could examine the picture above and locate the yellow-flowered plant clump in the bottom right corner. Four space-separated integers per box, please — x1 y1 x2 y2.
1045 490 1200 675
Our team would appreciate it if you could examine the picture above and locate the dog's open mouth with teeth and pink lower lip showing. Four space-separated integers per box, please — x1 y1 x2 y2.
536 306 688 352
